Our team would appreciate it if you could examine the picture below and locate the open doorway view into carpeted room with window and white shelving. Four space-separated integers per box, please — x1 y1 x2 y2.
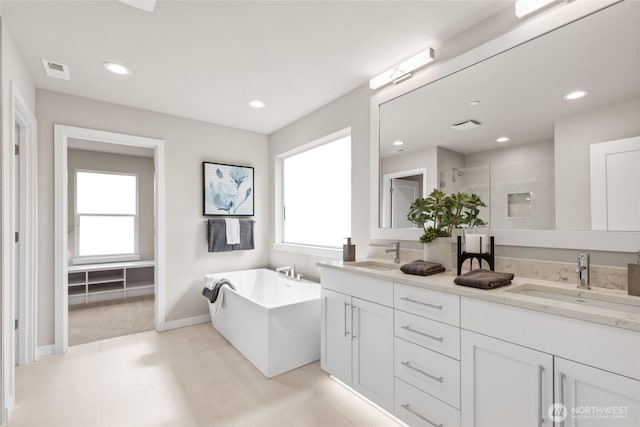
67 142 155 346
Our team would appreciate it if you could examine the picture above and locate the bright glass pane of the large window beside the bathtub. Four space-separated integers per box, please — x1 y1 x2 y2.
282 131 351 247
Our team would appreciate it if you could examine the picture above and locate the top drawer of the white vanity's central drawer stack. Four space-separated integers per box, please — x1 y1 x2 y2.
393 283 460 326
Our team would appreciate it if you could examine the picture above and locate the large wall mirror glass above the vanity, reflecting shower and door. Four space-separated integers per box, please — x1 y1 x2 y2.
372 1 640 250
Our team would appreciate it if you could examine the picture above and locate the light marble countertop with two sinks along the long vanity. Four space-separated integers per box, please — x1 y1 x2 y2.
317 259 640 331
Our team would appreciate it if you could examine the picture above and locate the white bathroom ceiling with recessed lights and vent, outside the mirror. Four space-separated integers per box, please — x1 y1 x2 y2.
2 0 513 134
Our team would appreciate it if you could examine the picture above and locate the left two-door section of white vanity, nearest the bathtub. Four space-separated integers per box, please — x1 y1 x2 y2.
320 269 394 412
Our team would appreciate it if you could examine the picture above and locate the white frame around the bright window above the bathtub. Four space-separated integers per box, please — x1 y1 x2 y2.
272 127 353 259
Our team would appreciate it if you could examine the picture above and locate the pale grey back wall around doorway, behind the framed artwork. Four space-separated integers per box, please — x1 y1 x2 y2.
37 90 270 346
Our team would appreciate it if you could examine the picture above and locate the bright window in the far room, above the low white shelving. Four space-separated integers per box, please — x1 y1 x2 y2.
75 171 138 257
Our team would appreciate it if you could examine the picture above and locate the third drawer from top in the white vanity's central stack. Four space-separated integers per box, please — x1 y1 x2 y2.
394 338 460 409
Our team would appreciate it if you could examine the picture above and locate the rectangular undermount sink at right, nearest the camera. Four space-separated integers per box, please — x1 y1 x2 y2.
507 283 640 314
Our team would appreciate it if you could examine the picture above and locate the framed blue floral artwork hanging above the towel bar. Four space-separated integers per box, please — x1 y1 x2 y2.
202 162 254 216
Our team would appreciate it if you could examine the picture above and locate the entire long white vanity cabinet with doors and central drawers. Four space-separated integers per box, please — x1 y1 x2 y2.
321 268 640 427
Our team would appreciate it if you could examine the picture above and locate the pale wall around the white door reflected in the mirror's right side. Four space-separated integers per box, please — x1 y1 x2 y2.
555 99 640 230
